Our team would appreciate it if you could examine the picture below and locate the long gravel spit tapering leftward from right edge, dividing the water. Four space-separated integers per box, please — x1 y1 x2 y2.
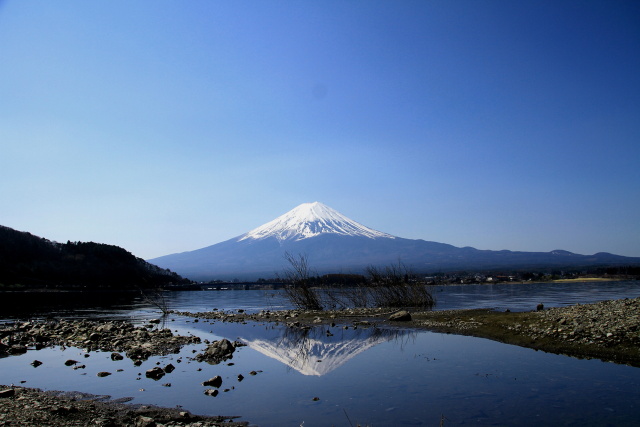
176 298 640 367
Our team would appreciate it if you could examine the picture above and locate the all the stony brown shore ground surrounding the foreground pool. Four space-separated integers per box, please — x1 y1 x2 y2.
0 298 640 427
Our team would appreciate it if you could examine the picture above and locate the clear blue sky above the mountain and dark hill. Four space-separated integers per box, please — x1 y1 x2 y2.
0 0 640 258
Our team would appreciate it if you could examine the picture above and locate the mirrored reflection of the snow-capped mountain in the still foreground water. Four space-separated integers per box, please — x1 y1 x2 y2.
243 327 410 376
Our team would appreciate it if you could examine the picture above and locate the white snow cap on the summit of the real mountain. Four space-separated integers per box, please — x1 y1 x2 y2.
238 202 395 241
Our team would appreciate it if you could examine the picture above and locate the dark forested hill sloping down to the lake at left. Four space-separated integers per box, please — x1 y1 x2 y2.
0 226 189 289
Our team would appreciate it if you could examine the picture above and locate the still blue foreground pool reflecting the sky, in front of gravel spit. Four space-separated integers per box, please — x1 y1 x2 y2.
0 318 640 426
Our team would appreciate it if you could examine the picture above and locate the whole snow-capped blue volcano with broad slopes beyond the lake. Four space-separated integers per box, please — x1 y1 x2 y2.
148 202 640 280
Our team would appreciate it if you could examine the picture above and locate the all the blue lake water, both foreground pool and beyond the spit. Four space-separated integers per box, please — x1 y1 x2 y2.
0 281 640 426
